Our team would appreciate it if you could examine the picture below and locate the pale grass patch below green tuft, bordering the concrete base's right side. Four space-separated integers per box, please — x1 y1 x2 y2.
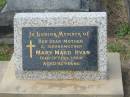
107 36 130 62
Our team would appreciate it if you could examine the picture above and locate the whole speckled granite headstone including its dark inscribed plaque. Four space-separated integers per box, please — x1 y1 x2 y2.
14 12 107 80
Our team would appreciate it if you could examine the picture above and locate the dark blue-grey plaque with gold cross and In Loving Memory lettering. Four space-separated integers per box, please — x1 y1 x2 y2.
22 26 98 70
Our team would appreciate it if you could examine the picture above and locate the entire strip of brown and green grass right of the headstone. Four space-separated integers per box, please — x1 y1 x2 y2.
101 0 130 62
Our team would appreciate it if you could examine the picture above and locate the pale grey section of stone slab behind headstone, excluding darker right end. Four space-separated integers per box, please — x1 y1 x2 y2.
7 0 81 11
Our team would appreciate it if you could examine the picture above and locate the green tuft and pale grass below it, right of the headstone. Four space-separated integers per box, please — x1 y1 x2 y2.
108 23 130 61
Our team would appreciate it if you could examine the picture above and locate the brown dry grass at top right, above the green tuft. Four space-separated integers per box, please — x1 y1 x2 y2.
101 0 128 37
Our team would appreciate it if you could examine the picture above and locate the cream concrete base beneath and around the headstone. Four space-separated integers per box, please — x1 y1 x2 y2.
0 53 123 97
